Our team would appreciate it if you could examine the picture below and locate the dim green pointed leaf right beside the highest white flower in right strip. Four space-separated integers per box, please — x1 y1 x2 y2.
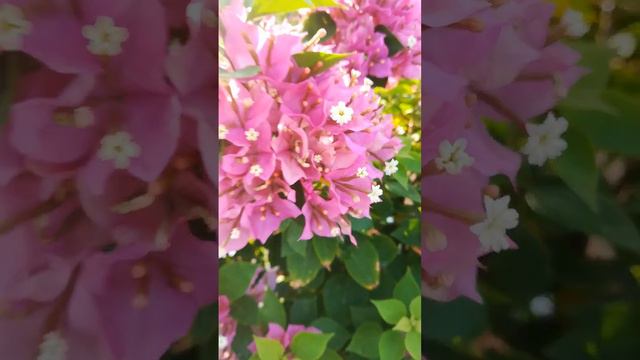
551 128 598 210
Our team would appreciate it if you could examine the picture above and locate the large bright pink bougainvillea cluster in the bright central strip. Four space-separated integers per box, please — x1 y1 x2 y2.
218 1 401 254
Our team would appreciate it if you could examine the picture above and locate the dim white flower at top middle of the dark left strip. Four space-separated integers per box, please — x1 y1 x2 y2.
82 16 129 56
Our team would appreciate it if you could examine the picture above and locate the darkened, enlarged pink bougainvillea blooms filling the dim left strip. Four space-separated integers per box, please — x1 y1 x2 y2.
0 0 217 360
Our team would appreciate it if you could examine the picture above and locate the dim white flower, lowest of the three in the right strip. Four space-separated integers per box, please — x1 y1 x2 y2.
469 195 518 252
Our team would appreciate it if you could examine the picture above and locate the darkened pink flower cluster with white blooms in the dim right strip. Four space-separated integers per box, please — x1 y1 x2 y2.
422 0 583 300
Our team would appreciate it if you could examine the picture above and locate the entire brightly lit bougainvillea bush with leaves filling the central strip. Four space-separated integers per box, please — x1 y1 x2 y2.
218 0 421 360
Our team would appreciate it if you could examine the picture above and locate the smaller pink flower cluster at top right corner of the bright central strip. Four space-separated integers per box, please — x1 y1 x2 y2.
330 0 421 79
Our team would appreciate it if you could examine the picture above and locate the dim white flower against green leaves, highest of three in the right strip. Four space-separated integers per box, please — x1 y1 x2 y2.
522 113 569 166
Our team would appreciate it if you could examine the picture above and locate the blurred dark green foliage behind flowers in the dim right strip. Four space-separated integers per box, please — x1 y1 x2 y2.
423 0 640 360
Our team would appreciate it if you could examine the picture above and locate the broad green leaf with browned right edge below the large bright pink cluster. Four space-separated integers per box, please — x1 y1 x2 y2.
344 240 380 290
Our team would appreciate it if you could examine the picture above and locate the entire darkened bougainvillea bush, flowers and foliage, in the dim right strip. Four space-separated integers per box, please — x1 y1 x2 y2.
422 0 640 359
